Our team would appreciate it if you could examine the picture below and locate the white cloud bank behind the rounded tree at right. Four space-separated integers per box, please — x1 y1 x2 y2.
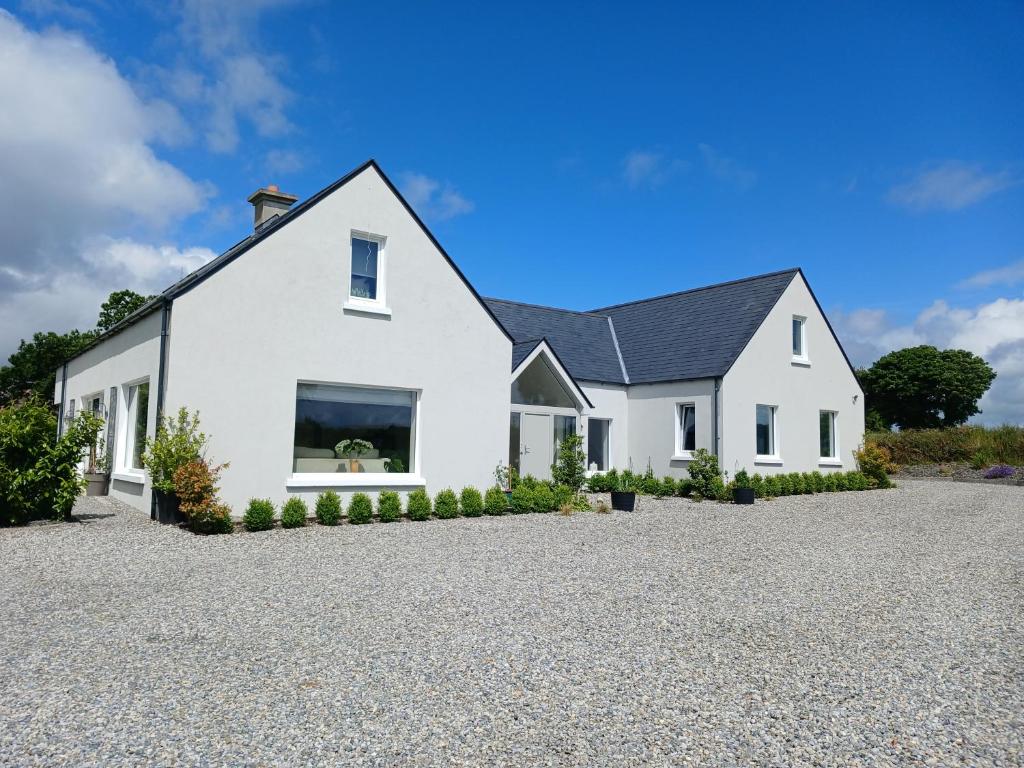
829 298 1024 424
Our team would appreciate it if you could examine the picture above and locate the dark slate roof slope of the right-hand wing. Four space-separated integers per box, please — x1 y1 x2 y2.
598 269 800 384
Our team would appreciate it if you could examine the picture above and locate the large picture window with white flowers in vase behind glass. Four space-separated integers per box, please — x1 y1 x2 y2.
293 384 416 473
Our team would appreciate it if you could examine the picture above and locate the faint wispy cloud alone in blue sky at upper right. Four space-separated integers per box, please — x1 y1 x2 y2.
888 161 1019 212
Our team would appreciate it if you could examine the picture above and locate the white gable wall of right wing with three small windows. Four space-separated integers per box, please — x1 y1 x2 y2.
722 275 864 476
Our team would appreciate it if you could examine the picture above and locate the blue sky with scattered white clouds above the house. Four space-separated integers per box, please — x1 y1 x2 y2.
0 0 1024 422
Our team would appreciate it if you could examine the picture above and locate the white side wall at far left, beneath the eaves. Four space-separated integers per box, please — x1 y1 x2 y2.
54 310 161 514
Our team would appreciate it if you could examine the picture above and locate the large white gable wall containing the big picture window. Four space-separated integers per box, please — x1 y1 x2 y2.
165 168 512 516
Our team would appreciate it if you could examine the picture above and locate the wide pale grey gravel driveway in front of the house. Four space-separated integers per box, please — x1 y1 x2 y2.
0 480 1024 766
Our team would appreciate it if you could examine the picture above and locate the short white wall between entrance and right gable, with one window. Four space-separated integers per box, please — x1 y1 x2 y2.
628 379 715 478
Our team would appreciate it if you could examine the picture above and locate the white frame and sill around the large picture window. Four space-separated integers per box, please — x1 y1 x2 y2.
285 379 426 488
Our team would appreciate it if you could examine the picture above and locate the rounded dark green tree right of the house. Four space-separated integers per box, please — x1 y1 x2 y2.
861 345 995 429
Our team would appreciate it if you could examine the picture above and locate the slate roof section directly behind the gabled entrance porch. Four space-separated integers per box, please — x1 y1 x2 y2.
483 299 626 384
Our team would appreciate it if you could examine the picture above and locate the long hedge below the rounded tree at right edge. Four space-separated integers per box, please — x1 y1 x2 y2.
864 425 1024 466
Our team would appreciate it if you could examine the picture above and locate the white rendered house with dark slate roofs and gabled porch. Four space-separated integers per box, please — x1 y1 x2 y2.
54 161 863 514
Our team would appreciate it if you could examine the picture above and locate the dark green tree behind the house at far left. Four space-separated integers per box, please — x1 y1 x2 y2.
0 331 96 406
